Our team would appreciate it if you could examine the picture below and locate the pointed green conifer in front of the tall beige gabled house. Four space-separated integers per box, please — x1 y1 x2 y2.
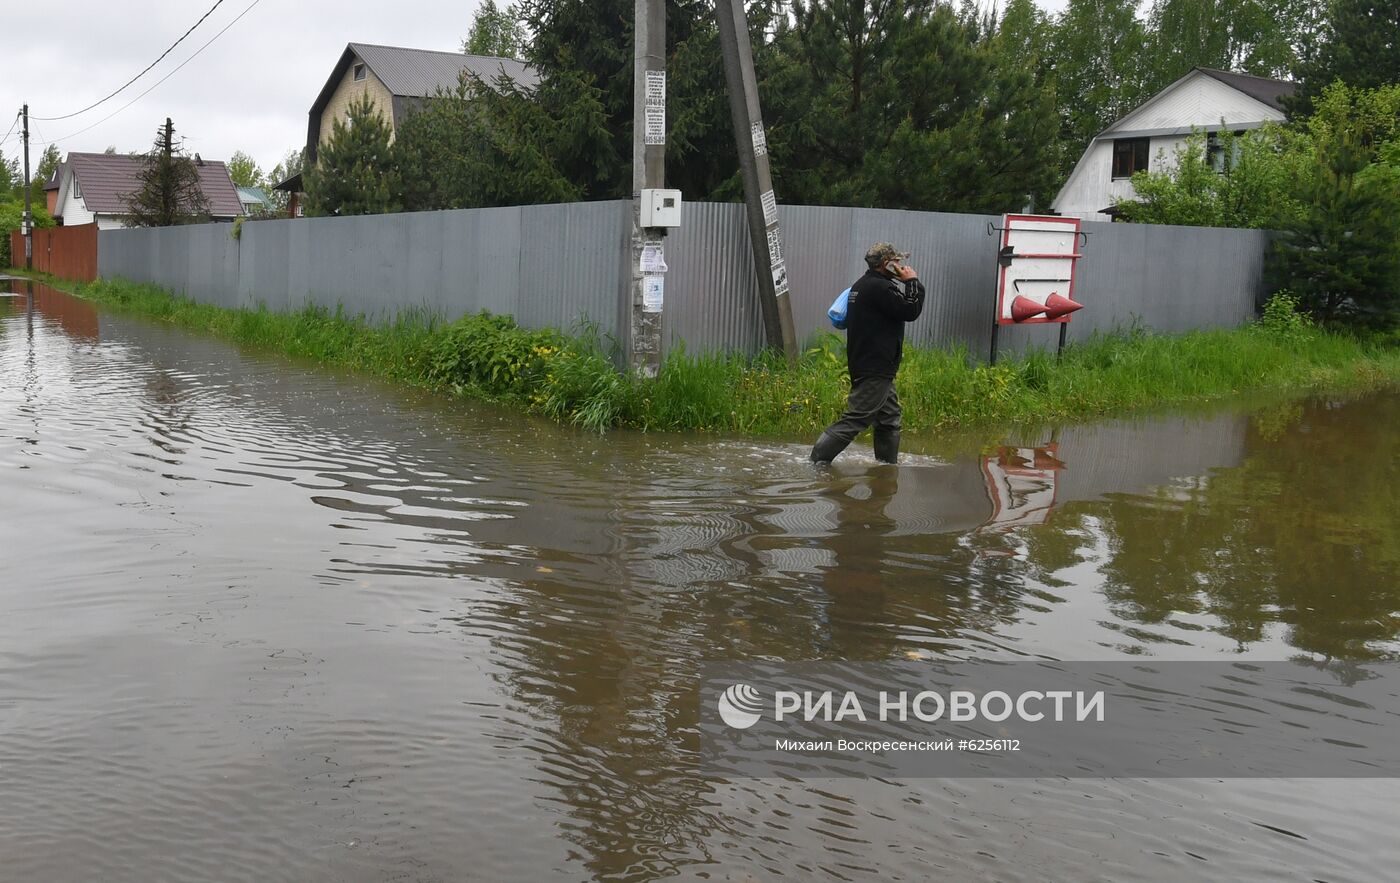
302 95 400 216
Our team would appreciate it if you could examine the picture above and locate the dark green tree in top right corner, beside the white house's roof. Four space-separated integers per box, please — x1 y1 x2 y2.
1289 0 1400 118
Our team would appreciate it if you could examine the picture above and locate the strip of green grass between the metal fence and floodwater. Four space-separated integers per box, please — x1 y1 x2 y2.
21 271 1400 435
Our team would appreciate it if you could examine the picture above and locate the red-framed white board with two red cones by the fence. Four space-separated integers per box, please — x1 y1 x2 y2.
997 214 1081 325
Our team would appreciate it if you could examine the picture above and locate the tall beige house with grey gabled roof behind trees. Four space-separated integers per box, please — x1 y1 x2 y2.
307 43 539 162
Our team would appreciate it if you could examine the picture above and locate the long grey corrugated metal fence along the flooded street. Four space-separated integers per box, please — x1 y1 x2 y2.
98 202 1268 354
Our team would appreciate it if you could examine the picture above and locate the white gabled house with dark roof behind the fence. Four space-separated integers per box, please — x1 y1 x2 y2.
1051 67 1294 221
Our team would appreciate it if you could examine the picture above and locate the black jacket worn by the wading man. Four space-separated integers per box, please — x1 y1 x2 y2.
846 270 924 383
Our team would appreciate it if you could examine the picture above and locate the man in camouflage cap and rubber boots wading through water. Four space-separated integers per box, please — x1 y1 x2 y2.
812 242 924 463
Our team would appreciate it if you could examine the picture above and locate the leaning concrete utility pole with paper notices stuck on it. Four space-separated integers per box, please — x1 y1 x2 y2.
715 0 798 361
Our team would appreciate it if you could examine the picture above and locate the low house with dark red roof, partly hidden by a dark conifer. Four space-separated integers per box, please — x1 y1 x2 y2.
55 151 244 229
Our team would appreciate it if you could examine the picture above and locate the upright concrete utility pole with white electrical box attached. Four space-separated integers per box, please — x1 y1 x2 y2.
629 0 666 376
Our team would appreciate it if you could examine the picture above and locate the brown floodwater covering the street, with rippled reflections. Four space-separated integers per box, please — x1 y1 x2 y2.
0 283 1400 883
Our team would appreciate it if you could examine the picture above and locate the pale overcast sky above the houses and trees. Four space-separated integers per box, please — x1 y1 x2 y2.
0 0 1067 181
